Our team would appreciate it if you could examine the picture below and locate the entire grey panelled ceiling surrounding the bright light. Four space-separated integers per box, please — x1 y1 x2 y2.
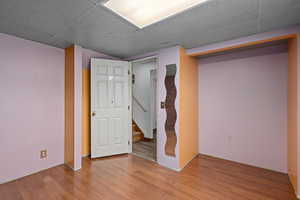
0 0 300 58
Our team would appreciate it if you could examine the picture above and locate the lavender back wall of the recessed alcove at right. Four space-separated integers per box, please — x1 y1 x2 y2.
199 45 288 173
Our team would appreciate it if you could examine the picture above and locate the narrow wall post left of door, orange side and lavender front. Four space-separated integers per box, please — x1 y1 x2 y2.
64 45 82 170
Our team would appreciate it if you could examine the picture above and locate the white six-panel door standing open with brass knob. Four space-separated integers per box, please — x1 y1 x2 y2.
91 59 130 158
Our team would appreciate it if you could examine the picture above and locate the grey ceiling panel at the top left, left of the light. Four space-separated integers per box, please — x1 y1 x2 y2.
5 0 93 35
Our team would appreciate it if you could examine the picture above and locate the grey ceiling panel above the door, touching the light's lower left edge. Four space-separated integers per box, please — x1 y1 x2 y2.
51 5 137 56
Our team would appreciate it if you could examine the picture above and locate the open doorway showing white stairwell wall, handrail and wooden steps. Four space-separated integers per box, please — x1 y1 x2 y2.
132 58 157 161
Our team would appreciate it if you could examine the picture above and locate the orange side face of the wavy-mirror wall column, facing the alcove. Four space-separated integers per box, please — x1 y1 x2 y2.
179 48 199 169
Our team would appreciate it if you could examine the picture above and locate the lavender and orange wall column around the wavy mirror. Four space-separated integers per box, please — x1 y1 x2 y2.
157 46 199 171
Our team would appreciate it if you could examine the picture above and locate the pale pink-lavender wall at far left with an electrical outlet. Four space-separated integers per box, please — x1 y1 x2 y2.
0 34 64 183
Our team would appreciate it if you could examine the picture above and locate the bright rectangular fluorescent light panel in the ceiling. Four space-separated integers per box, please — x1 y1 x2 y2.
104 0 208 28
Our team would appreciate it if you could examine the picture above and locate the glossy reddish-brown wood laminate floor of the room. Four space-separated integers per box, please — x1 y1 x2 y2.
0 155 296 200
